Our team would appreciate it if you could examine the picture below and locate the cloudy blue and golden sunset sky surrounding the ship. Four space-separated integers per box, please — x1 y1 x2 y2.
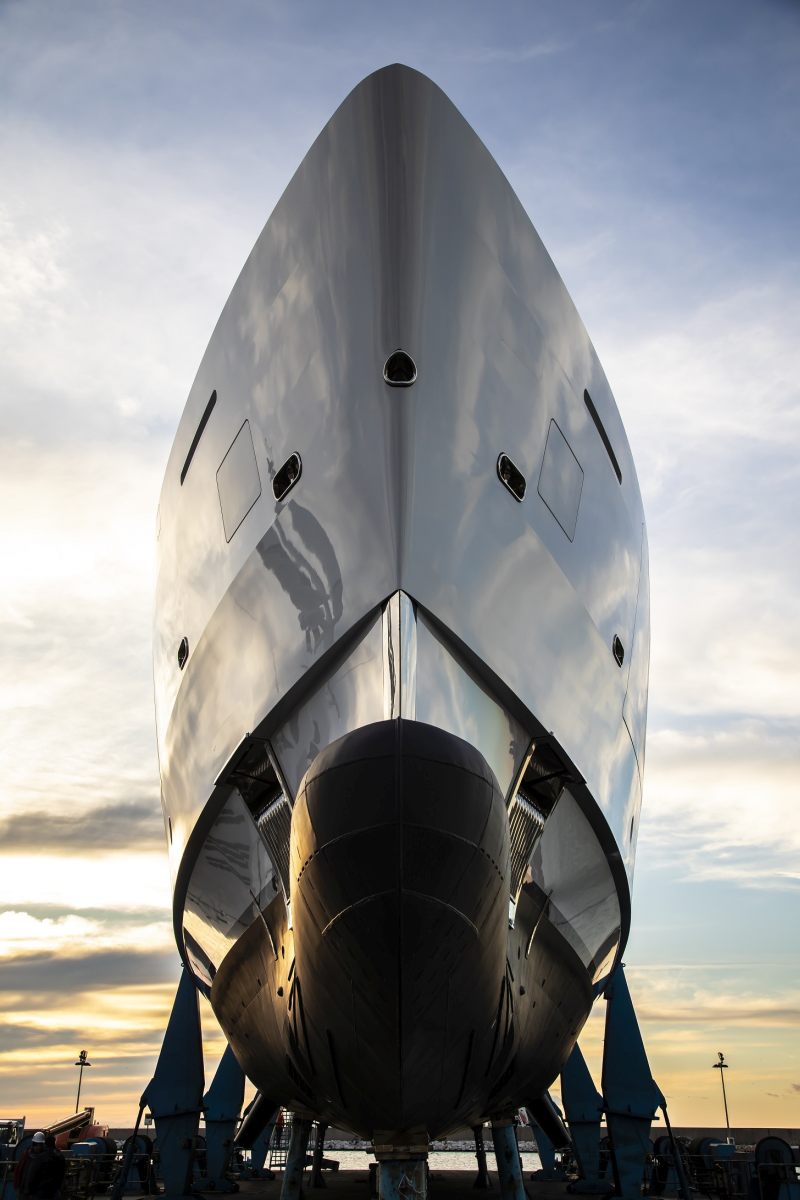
0 0 800 1128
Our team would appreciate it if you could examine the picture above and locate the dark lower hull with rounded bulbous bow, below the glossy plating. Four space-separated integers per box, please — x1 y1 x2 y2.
211 719 591 1136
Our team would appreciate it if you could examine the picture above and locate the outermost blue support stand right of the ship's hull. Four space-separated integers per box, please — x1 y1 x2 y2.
602 962 666 1200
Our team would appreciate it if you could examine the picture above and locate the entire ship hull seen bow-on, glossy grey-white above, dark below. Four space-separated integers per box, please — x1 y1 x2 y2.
155 67 649 1136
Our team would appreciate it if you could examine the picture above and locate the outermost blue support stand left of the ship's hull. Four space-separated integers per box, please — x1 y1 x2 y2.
142 970 204 1196
